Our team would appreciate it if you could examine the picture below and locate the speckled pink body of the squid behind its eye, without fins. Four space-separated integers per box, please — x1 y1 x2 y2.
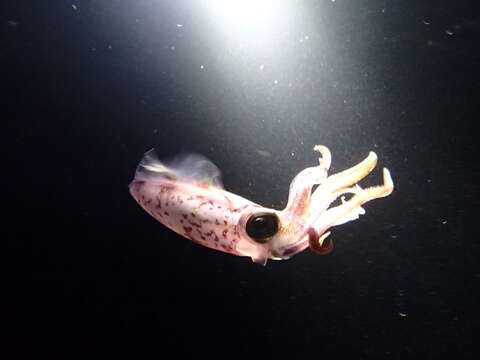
130 180 259 256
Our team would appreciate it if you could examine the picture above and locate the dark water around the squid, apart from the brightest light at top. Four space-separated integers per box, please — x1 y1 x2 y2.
4 0 480 359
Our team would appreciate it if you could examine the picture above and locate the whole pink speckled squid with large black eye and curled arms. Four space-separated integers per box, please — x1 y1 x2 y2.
129 145 394 265
